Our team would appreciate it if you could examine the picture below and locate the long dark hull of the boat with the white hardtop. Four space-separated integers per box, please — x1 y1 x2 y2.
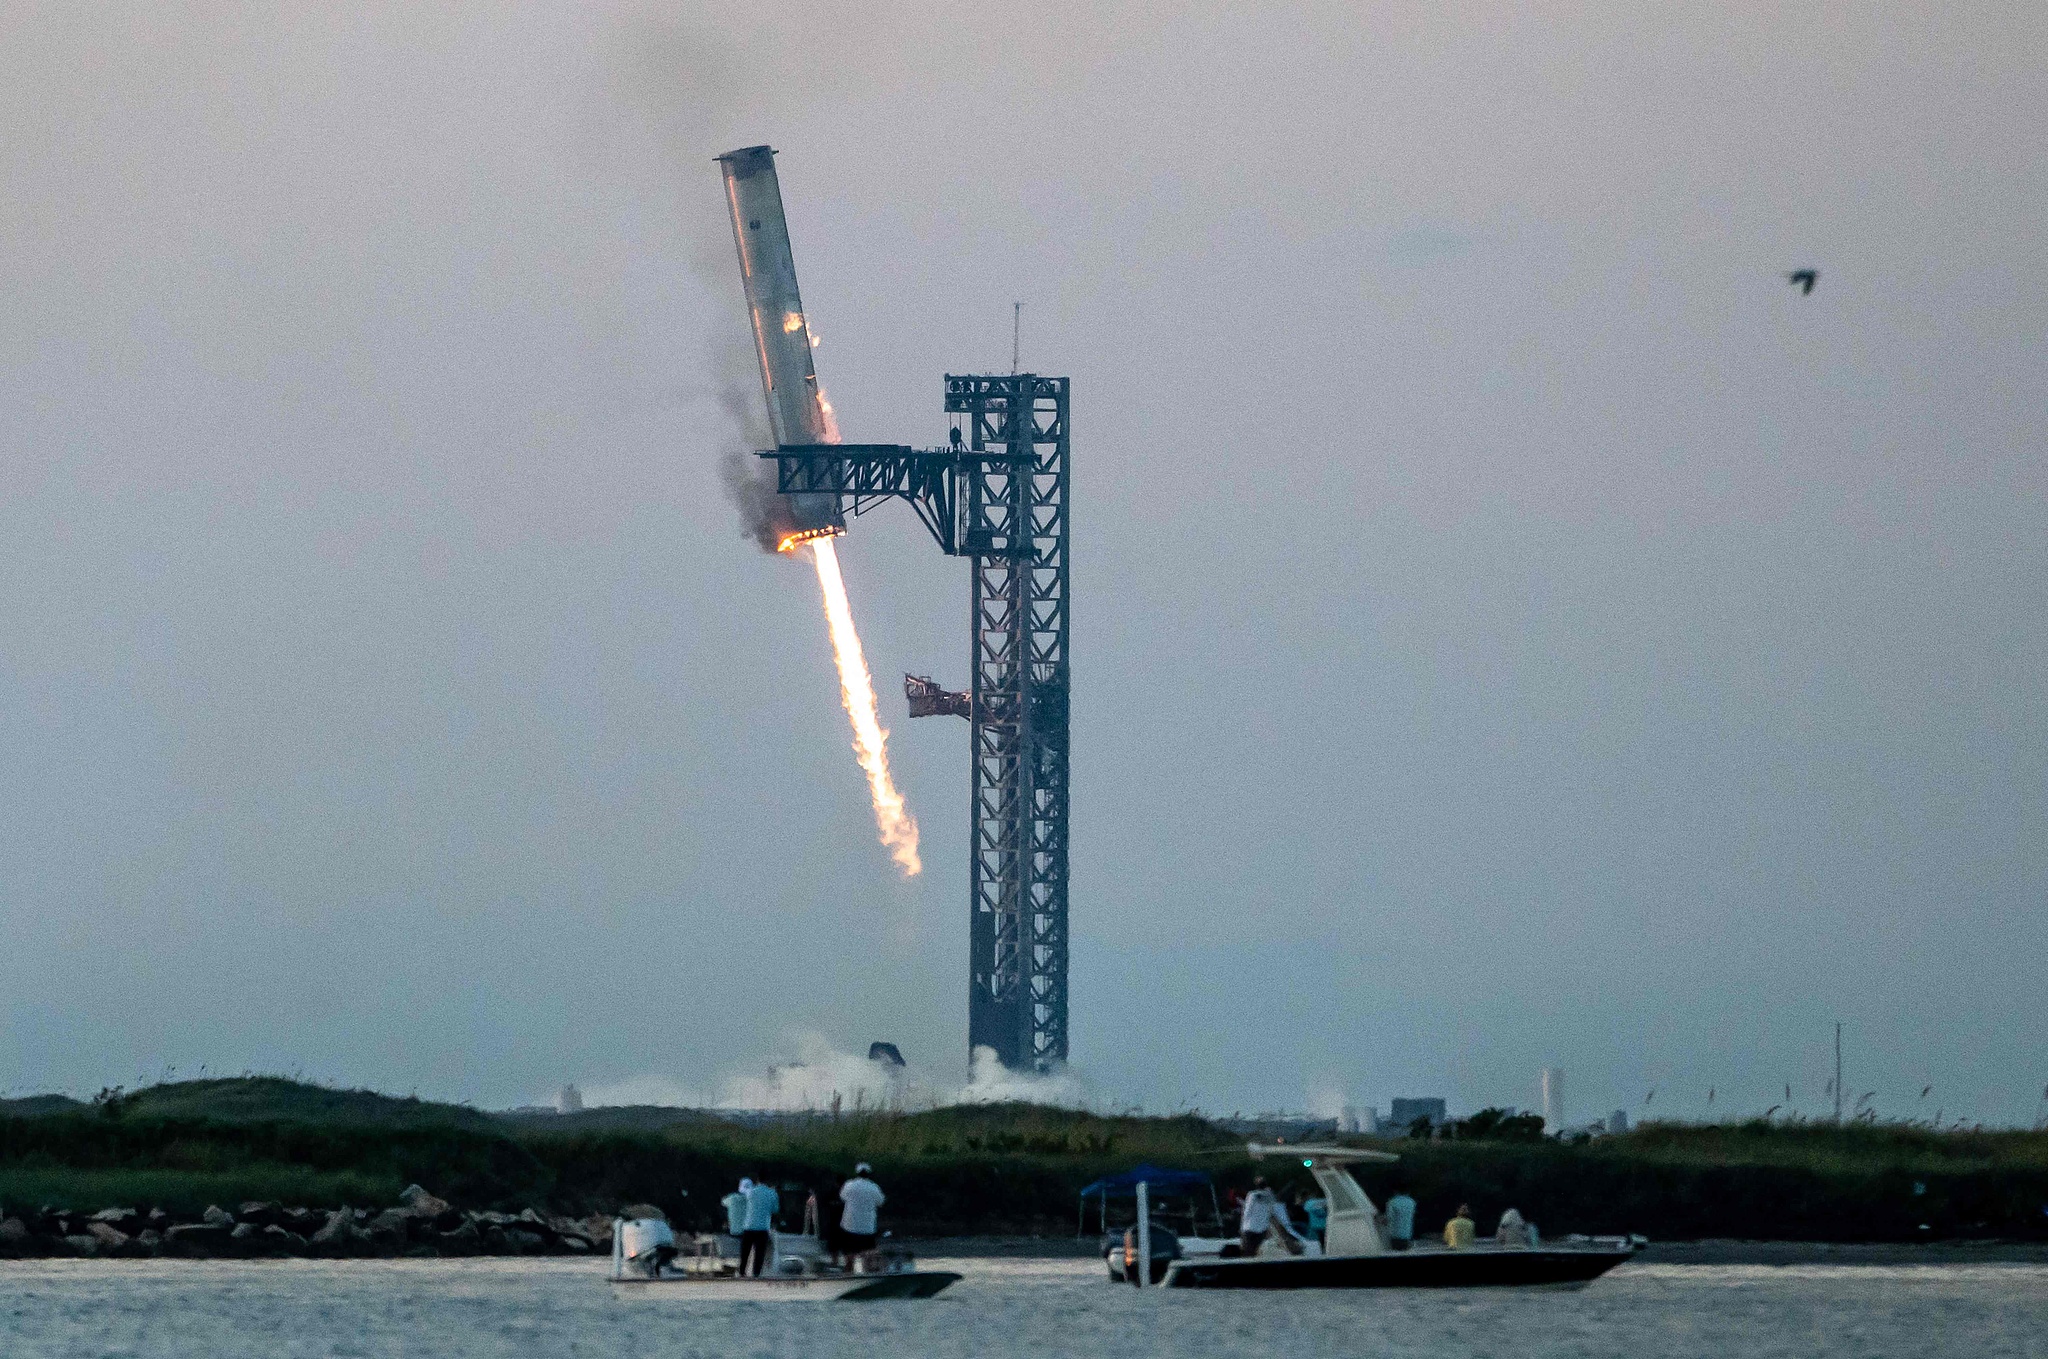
1165 1248 1634 1287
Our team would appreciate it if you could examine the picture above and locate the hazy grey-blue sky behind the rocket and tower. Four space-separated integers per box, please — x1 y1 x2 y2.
0 0 2048 1122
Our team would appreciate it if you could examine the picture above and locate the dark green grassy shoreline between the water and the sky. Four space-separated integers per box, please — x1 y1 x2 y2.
0 1079 2048 1242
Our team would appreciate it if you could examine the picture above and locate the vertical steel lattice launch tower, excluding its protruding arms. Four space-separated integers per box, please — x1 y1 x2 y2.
946 372 1069 1070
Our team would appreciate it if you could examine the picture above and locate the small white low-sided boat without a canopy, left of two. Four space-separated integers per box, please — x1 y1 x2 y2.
608 1218 961 1302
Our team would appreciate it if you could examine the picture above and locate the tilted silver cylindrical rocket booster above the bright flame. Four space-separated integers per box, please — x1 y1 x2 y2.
719 145 846 551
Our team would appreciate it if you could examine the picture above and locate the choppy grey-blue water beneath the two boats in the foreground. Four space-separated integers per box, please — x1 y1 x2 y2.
0 1261 2048 1359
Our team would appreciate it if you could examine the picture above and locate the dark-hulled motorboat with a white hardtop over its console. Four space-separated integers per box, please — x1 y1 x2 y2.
1155 1142 1638 1289
